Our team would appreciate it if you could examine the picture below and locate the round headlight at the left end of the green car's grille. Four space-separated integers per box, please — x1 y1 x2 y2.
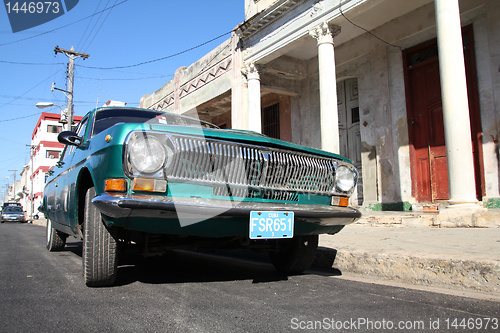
128 136 165 173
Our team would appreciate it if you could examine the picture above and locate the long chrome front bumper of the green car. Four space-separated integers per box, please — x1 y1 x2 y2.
92 193 361 226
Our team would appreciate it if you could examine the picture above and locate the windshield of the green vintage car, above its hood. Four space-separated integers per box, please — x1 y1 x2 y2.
93 109 218 135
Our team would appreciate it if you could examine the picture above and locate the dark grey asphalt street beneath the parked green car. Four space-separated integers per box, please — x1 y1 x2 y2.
0 223 500 332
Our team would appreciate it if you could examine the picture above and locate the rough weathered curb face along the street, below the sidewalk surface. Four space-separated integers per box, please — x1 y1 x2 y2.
314 247 500 295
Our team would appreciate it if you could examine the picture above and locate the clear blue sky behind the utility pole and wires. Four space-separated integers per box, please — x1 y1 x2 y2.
0 0 244 198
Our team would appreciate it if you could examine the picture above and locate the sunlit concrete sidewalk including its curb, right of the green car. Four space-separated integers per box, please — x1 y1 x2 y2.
315 221 500 300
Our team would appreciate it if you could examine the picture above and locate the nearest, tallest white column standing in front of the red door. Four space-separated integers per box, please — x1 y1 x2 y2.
434 0 477 204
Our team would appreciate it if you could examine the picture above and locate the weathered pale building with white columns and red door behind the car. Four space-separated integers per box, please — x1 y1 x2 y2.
141 0 500 210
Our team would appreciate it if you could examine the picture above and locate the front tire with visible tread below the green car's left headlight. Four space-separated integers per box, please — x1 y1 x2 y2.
82 187 118 287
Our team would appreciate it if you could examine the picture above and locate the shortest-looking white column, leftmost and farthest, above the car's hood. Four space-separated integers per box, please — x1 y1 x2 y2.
244 64 262 133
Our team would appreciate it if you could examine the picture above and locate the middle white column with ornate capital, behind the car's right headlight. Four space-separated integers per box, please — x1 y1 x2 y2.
309 22 340 154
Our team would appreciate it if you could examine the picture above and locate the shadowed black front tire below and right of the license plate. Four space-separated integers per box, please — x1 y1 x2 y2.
269 235 319 275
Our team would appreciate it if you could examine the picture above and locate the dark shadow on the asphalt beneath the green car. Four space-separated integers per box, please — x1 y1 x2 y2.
58 241 342 286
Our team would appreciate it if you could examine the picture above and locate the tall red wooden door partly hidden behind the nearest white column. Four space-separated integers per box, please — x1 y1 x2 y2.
404 27 484 202
